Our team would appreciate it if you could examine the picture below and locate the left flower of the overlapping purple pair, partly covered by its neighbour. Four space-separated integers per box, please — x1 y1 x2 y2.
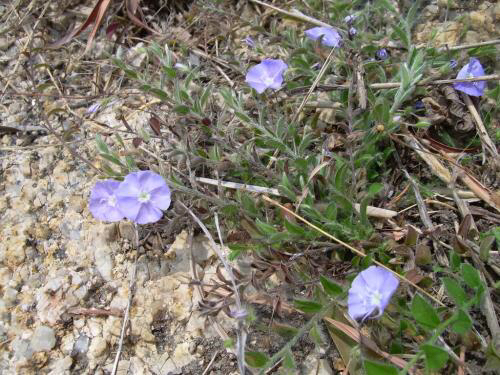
89 180 124 222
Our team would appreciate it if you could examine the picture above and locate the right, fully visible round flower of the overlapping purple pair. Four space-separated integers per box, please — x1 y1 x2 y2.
116 171 170 224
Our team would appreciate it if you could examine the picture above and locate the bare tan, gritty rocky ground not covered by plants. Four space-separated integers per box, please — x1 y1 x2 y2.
0 1 500 375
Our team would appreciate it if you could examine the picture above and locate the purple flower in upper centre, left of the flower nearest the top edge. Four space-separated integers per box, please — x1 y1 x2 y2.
246 59 288 94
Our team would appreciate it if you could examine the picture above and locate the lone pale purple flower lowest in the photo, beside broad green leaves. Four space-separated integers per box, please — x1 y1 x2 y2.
347 266 399 320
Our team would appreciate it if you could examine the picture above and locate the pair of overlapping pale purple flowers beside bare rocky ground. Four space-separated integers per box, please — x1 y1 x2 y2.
89 171 170 224
